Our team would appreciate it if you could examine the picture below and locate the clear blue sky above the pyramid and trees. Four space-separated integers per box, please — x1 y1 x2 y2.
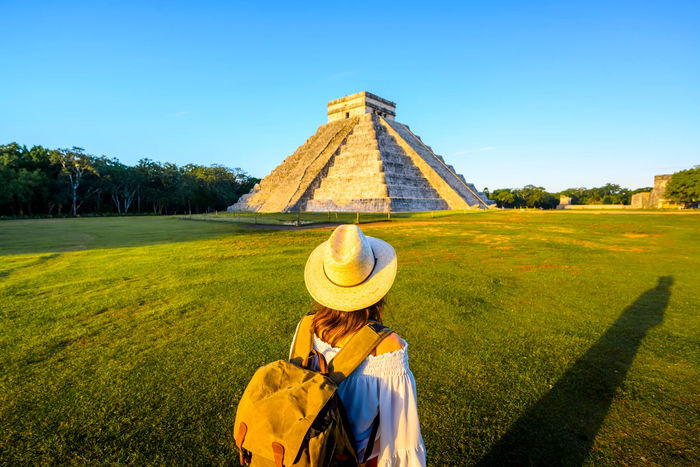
0 0 700 190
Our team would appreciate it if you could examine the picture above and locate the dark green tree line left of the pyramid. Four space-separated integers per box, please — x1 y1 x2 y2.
0 143 259 216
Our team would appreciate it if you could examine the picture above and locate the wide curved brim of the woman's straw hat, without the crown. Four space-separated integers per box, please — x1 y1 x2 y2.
304 237 396 311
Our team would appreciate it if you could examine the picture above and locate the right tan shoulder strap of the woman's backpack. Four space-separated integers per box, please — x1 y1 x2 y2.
328 321 393 384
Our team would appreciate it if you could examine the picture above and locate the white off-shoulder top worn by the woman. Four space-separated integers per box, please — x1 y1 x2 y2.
302 336 425 467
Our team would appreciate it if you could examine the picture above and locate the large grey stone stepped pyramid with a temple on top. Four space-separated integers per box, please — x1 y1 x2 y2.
228 92 493 212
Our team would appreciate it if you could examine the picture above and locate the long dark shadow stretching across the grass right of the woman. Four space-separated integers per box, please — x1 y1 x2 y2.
478 276 673 466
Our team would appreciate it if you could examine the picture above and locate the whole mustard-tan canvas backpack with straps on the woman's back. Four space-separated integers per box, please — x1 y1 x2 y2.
234 313 392 467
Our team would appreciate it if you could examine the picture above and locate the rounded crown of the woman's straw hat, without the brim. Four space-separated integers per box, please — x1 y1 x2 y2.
323 225 375 287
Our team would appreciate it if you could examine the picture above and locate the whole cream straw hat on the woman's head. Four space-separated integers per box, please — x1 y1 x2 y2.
304 225 396 311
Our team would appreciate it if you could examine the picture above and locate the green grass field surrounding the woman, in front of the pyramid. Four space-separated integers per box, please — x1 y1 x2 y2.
0 211 700 465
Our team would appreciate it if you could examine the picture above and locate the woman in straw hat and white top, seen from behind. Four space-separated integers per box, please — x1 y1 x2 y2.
292 225 425 466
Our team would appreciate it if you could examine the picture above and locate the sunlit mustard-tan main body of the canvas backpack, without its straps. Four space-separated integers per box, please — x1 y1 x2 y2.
234 360 337 465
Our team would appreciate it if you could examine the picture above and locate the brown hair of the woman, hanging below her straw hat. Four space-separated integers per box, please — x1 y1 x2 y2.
313 298 384 347
